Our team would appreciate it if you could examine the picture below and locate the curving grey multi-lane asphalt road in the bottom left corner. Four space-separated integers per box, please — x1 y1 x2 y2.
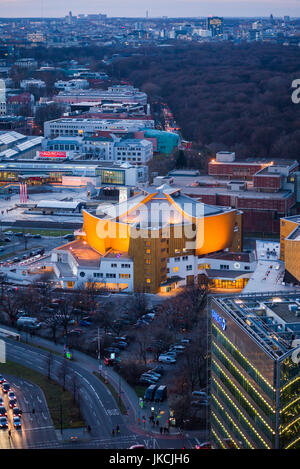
0 339 206 449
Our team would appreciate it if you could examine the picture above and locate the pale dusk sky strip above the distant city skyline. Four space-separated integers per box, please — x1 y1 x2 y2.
0 0 300 17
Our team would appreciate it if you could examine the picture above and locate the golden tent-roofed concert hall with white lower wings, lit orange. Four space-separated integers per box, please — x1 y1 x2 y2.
52 185 242 293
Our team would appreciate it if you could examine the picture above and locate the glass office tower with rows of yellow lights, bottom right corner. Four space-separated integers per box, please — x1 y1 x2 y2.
210 294 300 449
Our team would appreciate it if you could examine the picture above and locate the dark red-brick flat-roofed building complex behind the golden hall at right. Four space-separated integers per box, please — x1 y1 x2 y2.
162 152 300 234
